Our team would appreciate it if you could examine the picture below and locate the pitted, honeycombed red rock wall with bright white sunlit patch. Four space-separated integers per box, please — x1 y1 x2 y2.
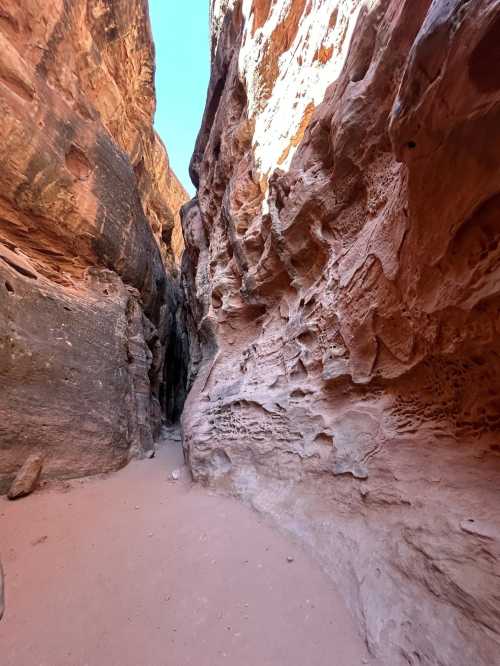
183 0 500 666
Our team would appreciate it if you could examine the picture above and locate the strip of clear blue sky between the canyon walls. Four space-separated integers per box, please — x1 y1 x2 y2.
149 0 210 194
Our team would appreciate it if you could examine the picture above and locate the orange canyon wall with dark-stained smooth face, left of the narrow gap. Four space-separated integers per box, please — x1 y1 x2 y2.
0 0 186 490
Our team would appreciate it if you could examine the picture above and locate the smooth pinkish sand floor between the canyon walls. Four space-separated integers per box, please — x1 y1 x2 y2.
0 428 371 666
